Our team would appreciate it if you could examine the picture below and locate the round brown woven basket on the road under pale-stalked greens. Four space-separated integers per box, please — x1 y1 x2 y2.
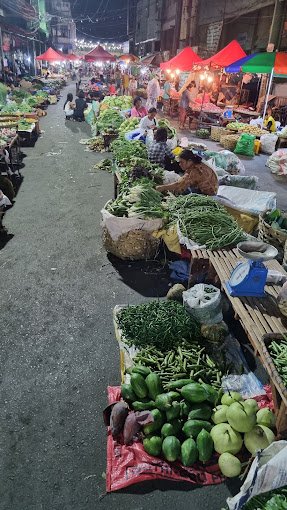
103 227 160 260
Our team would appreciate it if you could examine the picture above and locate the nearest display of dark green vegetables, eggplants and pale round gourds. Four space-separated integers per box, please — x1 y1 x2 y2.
106 365 275 478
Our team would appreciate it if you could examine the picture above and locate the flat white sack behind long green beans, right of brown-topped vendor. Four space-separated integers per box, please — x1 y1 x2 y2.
217 186 276 214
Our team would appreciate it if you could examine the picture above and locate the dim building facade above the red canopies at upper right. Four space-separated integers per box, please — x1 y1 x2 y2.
135 0 287 60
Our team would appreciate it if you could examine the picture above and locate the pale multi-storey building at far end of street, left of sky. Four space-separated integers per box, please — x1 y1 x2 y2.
47 0 76 53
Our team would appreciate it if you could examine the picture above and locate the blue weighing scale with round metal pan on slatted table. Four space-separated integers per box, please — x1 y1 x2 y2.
226 241 278 297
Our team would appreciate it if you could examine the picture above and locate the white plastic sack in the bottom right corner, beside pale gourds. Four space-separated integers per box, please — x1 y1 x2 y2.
227 441 287 510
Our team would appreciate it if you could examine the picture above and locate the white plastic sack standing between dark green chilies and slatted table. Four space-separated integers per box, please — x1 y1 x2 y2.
182 283 223 324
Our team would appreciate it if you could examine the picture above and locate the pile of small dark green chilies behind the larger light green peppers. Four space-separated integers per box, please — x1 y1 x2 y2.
118 301 200 351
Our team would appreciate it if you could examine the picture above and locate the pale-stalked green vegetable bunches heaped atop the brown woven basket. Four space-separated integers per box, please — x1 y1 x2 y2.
107 178 165 219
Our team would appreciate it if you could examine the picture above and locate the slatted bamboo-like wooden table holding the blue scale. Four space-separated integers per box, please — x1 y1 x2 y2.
189 249 287 437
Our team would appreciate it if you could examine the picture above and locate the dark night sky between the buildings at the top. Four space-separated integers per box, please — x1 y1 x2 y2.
70 0 128 42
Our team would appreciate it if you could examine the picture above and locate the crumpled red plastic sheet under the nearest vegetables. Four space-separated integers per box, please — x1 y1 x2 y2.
106 386 224 492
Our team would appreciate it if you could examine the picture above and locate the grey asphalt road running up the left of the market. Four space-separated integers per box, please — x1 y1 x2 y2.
0 85 266 510
